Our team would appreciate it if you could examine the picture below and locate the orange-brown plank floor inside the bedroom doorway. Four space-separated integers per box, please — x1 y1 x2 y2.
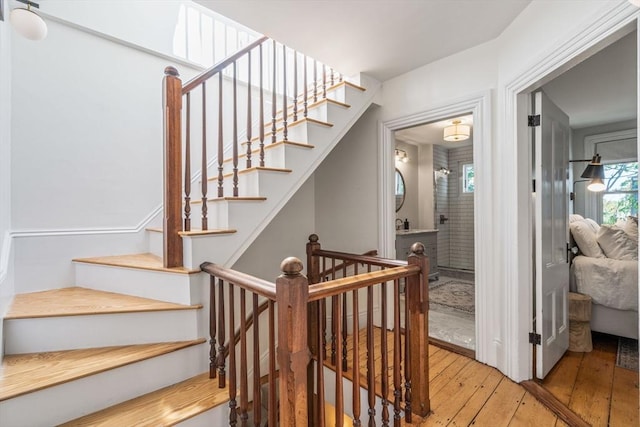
542 333 640 427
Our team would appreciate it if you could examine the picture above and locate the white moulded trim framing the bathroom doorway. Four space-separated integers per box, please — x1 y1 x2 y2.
378 90 492 366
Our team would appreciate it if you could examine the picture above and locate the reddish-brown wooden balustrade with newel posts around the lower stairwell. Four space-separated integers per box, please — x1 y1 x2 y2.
201 235 430 427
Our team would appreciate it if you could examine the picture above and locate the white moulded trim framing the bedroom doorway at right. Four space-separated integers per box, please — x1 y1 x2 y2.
502 2 638 382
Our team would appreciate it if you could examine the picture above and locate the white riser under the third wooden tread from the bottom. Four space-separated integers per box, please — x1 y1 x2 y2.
4 309 198 354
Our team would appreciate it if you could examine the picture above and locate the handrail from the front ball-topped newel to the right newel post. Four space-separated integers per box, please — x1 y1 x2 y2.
309 265 420 302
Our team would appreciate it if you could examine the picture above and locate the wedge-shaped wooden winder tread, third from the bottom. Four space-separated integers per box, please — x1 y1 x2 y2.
5 287 202 320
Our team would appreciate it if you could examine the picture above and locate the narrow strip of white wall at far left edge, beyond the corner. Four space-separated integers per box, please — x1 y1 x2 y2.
0 11 14 358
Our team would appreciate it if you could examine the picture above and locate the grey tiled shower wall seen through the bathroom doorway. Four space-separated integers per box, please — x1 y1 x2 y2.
433 146 475 270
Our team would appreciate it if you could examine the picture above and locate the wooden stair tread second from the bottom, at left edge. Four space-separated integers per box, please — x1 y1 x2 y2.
0 339 205 402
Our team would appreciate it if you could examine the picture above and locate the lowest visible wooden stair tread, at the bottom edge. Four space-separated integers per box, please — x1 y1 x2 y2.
61 373 229 427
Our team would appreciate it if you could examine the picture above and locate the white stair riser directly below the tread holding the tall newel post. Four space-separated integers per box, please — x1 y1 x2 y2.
76 263 201 305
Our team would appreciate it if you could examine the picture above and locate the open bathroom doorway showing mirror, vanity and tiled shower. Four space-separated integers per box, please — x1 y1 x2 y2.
394 114 476 351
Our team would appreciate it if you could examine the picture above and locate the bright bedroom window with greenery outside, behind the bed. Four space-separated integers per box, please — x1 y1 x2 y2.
602 162 638 224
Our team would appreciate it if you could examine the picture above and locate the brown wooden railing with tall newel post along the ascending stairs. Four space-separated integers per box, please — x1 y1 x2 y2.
163 37 343 267
